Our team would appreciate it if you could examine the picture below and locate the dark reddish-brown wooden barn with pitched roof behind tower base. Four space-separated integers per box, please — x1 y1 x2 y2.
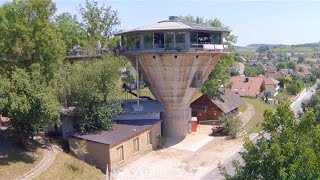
190 90 244 121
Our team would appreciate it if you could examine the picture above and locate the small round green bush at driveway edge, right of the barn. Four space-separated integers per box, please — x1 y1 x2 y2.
219 114 241 139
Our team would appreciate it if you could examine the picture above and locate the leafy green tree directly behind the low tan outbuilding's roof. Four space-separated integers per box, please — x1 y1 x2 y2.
63 56 124 132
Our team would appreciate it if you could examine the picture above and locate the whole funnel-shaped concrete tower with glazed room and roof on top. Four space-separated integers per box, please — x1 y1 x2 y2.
117 16 229 138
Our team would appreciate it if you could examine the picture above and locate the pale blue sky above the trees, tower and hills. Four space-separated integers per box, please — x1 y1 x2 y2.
0 0 320 45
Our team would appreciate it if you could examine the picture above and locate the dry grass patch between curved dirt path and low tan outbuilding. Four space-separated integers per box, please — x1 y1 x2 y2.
35 152 105 180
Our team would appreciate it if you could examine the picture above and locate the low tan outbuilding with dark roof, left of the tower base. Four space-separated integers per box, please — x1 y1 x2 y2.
68 119 161 171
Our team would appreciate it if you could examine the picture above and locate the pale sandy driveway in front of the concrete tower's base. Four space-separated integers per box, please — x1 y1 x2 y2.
112 125 243 179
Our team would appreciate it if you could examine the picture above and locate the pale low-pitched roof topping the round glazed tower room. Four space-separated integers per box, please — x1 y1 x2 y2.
116 16 230 35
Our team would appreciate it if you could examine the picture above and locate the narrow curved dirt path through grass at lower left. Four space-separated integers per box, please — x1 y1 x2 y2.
16 145 58 180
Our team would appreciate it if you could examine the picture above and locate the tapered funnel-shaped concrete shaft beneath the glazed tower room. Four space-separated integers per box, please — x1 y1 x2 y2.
129 52 222 137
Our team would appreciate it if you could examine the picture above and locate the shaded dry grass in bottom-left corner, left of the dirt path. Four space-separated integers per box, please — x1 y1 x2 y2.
0 147 44 179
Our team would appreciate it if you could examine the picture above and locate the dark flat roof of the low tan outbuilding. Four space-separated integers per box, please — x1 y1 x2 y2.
70 120 161 147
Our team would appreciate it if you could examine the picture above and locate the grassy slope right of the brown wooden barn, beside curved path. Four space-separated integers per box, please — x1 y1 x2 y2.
243 98 273 133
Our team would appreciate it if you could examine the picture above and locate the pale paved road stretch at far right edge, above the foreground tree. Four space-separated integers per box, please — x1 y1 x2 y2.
290 84 317 116
